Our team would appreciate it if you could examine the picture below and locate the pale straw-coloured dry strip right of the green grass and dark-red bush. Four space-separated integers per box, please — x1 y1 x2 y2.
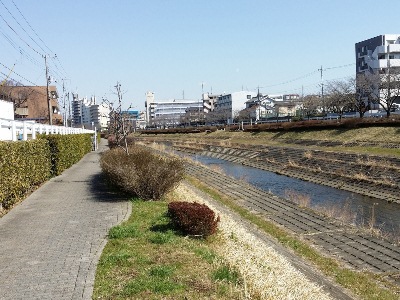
176 184 330 299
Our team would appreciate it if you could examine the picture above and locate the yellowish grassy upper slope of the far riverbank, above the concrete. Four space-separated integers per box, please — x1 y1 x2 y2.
133 126 400 157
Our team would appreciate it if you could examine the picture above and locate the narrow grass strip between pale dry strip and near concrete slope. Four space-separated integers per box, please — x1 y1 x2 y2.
187 176 400 300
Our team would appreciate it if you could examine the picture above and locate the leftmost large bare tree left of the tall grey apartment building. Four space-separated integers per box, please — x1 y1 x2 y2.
325 79 356 120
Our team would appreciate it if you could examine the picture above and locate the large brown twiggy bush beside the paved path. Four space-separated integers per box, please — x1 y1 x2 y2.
100 146 184 200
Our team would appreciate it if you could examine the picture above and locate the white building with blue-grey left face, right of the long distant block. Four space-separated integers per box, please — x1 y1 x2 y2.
214 91 257 124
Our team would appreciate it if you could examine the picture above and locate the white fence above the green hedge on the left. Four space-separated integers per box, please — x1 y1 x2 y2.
0 119 96 141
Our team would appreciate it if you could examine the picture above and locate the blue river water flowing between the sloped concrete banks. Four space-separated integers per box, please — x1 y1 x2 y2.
187 155 400 236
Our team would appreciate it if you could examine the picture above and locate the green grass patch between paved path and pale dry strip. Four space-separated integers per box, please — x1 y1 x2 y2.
93 200 243 299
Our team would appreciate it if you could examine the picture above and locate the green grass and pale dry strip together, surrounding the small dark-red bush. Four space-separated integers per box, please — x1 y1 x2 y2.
93 184 331 299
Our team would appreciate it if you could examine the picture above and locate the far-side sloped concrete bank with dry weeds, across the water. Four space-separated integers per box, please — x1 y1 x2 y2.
136 139 400 203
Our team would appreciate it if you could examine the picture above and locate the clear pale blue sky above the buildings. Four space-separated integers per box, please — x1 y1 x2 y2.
0 0 400 110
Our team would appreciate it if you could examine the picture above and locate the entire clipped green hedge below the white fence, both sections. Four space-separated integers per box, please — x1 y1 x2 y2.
0 134 92 209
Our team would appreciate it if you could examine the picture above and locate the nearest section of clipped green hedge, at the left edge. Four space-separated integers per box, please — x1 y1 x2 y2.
0 140 51 209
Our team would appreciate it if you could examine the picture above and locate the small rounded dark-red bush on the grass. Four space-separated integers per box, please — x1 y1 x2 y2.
168 202 220 237
